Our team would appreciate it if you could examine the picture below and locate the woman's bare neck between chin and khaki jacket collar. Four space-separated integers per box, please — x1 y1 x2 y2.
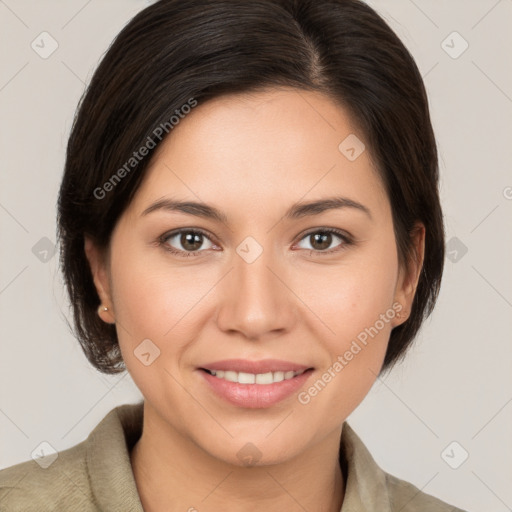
130 401 345 512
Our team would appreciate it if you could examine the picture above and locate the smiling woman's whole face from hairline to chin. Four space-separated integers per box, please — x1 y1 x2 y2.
86 89 422 464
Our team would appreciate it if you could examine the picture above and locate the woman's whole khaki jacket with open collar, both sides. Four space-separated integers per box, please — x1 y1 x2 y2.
0 402 464 512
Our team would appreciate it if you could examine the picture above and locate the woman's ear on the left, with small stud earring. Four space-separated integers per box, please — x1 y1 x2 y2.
84 235 115 323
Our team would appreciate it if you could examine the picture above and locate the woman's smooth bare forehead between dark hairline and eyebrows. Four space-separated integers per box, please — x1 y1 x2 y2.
127 89 388 222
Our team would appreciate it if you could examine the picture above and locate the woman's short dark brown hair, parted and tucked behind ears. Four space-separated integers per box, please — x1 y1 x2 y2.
57 0 445 374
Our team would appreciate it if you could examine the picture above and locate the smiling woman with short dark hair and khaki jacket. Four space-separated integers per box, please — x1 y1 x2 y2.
0 0 468 512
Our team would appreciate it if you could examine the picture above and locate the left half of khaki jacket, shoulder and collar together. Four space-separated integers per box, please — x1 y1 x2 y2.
0 403 143 512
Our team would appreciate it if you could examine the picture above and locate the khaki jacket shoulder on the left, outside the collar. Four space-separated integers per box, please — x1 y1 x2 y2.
0 441 97 512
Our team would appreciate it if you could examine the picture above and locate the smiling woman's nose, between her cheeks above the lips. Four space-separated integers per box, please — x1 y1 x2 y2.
217 243 299 341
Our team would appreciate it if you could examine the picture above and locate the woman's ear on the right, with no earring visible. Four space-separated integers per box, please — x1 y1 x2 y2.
394 222 426 327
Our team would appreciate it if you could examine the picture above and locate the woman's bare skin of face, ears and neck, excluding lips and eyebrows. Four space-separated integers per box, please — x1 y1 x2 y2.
85 88 425 512
